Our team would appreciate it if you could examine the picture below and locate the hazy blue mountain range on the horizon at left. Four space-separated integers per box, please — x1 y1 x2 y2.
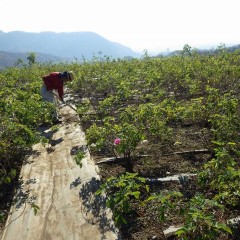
0 31 140 66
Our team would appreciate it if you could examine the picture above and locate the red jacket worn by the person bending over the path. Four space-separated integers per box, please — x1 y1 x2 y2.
43 72 63 100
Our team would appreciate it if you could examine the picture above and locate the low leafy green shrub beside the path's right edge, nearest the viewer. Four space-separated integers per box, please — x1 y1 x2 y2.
96 173 149 226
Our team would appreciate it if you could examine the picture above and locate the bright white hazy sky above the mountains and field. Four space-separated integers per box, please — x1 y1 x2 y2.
0 0 240 53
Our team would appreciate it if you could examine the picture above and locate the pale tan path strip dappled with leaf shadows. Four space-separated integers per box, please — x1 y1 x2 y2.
2 106 120 240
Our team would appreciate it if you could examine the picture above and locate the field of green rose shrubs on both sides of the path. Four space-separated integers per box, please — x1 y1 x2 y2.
0 46 240 240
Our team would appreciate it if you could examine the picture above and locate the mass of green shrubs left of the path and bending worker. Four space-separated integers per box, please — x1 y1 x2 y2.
0 60 77 193
